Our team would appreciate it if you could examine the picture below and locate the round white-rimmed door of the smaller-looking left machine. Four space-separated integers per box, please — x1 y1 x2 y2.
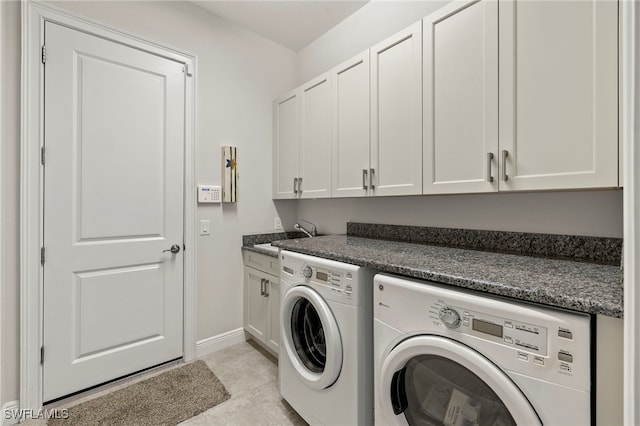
280 285 342 389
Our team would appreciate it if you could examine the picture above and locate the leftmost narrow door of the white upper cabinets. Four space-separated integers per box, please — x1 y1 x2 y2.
272 90 300 199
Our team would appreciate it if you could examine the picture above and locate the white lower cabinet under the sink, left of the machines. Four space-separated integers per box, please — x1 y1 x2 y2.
243 251 280 355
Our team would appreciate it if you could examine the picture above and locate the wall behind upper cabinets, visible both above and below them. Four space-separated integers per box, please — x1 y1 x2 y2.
298 1 622 237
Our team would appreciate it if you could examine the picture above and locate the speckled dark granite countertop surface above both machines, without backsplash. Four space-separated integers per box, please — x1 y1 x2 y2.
273 235 623 318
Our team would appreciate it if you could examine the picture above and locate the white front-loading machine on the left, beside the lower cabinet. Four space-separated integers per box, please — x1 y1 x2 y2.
278 251 374 425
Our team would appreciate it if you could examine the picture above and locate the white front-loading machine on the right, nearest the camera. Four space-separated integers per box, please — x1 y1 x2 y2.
373 274 595 426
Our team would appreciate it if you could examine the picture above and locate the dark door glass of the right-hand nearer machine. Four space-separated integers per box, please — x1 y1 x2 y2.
391 355 516 426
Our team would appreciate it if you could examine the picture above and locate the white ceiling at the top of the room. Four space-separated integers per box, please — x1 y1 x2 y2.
194 0 369 52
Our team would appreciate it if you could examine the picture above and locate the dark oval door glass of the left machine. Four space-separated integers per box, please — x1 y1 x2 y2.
291 298 327 373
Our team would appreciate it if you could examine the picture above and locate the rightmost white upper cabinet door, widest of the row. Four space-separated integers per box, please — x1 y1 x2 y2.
499 0 618 190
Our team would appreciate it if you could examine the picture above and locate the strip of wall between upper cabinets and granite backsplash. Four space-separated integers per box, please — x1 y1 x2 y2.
298 190 622 238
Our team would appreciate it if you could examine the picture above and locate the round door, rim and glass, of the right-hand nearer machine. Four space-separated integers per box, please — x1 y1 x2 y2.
376 335 542 426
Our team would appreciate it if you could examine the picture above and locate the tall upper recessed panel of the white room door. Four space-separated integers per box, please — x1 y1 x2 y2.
74 54 166 240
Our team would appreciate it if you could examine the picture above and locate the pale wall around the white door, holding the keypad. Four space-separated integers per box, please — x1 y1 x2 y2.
0 1 297 405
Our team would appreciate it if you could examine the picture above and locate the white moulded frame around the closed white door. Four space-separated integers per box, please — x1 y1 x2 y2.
20 0 197 410
